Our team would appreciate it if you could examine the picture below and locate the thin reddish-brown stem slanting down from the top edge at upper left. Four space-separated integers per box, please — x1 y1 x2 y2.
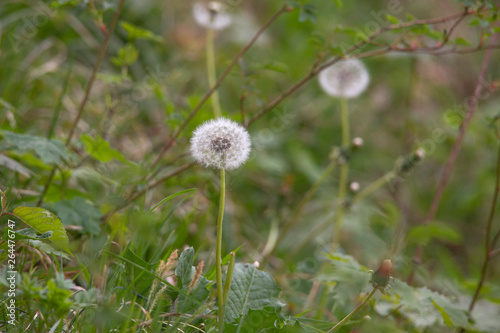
37 0 125 206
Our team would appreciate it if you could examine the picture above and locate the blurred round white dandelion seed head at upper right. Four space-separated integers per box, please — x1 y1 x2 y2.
319 59 370 98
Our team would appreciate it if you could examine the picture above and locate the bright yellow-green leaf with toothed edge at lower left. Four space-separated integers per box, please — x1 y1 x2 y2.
13 207 71 254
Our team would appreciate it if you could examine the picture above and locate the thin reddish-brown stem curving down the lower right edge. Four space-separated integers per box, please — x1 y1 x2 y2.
469 146 500 313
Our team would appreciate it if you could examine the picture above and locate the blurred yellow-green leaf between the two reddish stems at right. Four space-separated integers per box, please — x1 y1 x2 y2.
406 222 462 245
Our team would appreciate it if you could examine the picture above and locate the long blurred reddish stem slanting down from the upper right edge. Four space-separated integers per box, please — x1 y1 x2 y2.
408 31 498 284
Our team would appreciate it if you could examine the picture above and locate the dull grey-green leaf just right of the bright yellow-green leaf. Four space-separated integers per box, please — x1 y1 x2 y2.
51 197 102 235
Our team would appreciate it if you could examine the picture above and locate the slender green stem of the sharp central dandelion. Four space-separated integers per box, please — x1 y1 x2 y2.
215 169 226 333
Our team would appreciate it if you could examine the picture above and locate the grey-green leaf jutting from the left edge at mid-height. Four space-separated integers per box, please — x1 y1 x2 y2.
0 131 68 164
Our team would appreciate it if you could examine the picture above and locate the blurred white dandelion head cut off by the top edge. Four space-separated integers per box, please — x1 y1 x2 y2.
193 1 231 30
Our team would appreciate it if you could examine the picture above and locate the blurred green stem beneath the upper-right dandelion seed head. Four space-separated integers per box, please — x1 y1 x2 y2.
332 97 350 253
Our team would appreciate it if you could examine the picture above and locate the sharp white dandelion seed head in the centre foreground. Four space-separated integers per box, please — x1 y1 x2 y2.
191 118 251 170
